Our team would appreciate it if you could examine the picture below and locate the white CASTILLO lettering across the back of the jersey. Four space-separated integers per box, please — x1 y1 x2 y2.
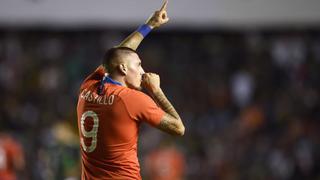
80 89 114 105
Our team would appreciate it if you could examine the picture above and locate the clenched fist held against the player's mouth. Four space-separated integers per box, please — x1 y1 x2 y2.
141 73 160 93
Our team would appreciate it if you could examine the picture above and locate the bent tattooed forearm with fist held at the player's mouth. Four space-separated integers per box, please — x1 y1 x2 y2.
142 73 185 136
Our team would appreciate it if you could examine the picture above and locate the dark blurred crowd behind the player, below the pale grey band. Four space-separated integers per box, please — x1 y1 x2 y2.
0 30 320 180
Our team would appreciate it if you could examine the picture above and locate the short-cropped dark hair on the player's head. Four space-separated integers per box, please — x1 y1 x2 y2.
102 47 136 74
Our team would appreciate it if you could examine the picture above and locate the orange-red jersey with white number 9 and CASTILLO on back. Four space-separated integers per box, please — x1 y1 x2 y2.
77 67 164 180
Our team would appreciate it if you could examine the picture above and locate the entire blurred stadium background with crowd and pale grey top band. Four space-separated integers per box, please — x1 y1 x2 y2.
0 0 320 180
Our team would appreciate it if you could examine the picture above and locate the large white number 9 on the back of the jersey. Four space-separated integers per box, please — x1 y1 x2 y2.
81 111 99 153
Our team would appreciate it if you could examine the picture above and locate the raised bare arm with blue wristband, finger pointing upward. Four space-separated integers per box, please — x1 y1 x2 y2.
117 0 169 50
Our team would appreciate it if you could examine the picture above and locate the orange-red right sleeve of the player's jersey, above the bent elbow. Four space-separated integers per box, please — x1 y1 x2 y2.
124 91 164 126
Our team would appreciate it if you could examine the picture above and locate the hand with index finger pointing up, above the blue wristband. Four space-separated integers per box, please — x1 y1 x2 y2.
146 0 169 28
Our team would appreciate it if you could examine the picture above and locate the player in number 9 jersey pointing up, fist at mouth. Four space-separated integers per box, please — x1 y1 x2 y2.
77 1 185 180
